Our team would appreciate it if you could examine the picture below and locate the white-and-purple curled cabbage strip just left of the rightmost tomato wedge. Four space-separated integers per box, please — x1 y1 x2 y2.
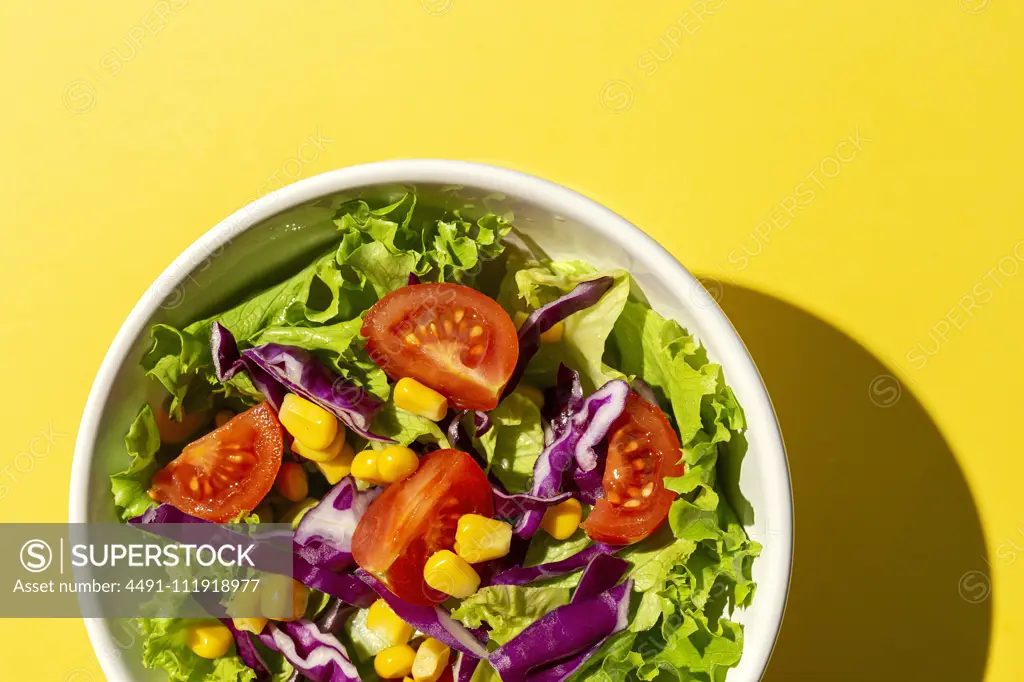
515 379 630 538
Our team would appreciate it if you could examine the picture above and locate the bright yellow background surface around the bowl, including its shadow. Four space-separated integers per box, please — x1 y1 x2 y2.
0 0 1024 682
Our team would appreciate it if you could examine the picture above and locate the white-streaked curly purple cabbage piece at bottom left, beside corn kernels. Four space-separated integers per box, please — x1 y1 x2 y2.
259 620 359 682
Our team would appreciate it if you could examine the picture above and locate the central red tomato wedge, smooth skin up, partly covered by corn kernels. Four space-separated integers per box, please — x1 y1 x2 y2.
352 450 495 605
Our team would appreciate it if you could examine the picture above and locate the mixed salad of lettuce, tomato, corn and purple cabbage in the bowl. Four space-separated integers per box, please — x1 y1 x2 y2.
86 174 774 682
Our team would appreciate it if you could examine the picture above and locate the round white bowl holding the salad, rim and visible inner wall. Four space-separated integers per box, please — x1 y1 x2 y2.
70 160 793 682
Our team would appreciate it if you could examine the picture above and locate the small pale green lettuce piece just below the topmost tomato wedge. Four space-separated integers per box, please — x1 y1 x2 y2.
475 391 544 493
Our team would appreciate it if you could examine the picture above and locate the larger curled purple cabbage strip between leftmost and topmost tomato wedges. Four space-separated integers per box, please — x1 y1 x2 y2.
242 343 387 440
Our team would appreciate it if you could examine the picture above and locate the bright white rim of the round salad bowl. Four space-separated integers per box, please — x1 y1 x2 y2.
69 159 794 682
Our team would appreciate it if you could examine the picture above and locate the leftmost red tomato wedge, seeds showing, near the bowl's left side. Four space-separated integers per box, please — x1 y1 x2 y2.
150 402 285 523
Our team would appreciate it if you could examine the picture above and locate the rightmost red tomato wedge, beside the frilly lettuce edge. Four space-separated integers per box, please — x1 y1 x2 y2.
583 392 684 545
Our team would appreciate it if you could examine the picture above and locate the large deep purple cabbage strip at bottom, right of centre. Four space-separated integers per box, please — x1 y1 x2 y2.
488 580 633 682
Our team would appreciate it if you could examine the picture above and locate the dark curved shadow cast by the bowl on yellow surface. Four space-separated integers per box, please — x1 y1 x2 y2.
719 285 991 682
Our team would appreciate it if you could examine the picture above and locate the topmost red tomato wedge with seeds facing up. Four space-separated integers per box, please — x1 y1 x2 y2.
361 284 519 410
